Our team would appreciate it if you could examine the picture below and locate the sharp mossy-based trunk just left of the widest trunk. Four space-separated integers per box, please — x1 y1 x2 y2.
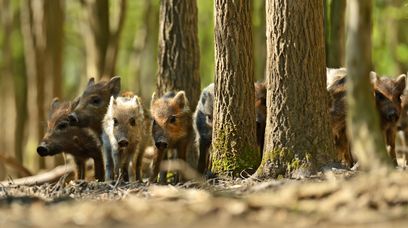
211 0 260 175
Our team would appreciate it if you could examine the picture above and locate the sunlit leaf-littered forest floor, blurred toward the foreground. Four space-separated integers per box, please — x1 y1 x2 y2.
0 166 408 228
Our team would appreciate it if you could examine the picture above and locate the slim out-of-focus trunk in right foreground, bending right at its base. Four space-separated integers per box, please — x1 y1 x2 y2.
346 0 391 170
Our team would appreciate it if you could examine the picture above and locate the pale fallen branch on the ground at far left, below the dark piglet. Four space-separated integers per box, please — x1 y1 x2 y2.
0 164 75 187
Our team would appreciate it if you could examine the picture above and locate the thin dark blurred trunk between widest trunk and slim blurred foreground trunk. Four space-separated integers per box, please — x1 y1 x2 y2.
327 0 346 68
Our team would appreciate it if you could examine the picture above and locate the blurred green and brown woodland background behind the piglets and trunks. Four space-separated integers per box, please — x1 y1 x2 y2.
0 0 408 180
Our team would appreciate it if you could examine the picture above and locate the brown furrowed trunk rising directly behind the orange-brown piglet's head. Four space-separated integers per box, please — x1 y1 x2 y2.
156 0 200 110
